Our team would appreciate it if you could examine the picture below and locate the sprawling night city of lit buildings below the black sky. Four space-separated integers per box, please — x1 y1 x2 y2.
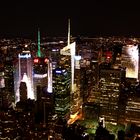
0 34 140 140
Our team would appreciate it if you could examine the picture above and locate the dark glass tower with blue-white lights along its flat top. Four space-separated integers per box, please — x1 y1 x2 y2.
53 68 70 120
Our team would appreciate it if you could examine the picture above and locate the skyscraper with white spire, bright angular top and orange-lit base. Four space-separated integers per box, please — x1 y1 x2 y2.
60 20 80 123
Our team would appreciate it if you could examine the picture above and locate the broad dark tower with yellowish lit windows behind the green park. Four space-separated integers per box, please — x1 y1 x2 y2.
99 65 125 122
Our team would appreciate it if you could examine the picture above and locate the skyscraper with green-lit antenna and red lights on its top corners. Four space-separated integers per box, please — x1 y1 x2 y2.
33 29 52 99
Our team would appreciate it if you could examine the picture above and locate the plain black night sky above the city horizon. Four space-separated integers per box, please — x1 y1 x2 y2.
0 0 140 37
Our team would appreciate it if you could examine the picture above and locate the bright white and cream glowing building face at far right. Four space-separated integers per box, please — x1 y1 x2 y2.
122 45 139 79
